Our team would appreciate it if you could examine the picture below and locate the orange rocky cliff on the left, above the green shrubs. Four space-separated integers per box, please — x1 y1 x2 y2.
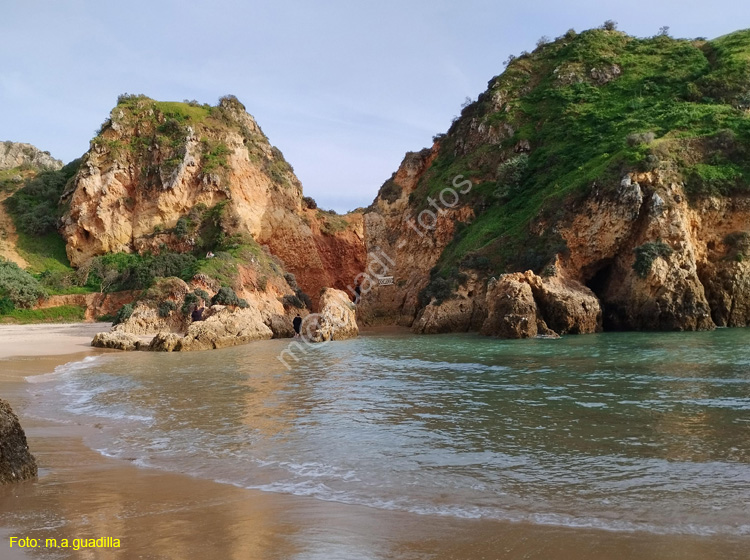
61 95 364 307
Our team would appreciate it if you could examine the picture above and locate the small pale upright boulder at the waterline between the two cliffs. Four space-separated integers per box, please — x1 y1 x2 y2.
302 288 359 342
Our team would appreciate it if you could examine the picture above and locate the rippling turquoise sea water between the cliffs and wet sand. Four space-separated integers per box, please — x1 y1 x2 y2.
29 329 750 535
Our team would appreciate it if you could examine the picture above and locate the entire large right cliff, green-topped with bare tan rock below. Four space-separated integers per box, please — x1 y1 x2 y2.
360 29 750 337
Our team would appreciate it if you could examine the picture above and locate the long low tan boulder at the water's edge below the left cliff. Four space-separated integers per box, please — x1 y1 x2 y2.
149 305 273 352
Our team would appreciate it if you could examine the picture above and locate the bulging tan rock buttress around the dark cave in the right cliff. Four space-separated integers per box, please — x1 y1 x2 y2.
561 172 714 330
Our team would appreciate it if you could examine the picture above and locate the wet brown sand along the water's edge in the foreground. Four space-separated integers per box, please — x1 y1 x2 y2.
0 326 750 560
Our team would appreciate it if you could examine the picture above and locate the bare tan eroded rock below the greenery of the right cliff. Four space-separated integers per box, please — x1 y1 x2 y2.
362 158 750 336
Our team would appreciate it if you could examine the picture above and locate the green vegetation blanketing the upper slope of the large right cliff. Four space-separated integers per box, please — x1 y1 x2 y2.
412 25 750 278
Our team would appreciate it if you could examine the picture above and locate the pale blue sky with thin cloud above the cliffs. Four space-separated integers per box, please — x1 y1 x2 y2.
0 0 749 212
